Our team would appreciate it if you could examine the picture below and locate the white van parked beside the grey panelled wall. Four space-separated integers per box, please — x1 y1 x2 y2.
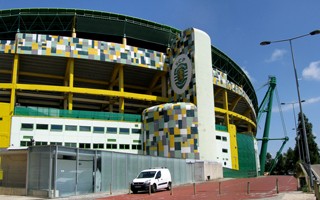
131 168 172 194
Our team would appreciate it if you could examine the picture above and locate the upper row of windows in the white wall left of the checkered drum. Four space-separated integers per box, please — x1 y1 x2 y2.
21 123 141 134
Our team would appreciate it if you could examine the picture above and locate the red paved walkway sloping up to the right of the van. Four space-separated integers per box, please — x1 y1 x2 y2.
99 176 297 200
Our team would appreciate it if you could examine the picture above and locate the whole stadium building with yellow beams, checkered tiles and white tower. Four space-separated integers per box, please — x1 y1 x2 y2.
0 8 259 177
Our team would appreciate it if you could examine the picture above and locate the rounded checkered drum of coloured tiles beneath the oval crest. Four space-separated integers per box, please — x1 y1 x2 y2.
142 103 199 159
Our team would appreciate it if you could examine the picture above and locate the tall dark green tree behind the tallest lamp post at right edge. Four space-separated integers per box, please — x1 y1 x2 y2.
294 113 320 164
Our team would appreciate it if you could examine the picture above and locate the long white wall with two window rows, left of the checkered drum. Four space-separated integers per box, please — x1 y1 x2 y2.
10 116 143 154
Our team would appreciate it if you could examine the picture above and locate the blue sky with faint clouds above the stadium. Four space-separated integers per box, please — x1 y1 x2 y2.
0 0 320 155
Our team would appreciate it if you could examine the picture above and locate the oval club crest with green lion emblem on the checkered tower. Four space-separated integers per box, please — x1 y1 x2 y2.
170 54 192 94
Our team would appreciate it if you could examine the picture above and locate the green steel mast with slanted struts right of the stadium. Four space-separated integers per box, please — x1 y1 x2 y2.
257 76 289 175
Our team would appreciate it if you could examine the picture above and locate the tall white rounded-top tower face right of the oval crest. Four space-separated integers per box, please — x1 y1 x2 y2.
194 29 217 161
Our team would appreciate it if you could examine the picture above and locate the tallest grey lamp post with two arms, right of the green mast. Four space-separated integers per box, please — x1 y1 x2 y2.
260 30 320 187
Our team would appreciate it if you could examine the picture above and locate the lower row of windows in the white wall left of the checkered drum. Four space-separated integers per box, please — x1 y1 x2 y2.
20 141 142 150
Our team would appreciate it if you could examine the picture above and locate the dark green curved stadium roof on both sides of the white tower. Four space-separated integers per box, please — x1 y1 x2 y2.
0 8 258 112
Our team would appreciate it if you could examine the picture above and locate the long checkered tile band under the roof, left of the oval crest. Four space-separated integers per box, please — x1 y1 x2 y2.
0 33 166 71
